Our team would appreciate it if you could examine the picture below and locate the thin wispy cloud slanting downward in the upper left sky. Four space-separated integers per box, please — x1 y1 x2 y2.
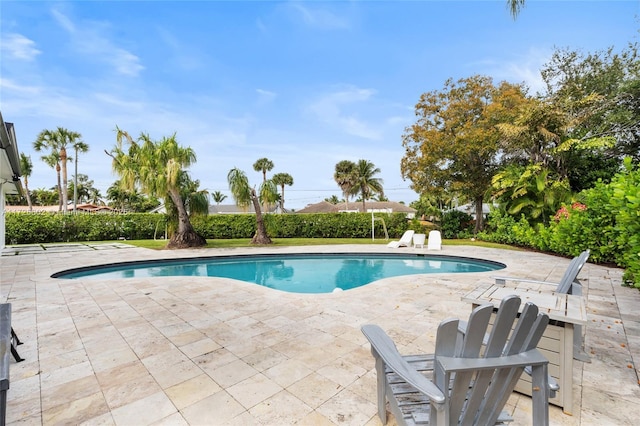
51 9 144 77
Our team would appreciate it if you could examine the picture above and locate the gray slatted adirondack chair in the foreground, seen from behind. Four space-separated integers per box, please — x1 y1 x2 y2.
362 296 551 425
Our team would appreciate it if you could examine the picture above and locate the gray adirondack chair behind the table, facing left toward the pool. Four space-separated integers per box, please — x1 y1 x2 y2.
494 250 591 362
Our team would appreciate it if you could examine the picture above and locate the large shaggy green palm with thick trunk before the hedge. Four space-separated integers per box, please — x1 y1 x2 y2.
105 127 207 248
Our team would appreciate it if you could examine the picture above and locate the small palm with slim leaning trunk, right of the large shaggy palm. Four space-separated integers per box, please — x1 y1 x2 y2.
227 168 277 244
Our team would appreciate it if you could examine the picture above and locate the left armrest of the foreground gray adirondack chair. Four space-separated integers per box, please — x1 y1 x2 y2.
361 324 445 404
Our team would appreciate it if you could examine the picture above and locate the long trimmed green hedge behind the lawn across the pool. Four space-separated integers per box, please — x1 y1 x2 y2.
6 213 418 244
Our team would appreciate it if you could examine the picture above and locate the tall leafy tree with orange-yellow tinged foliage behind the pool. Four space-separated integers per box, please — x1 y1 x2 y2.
401 75 524 232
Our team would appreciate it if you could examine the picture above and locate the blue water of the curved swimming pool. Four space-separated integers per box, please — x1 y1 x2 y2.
52 254 505 293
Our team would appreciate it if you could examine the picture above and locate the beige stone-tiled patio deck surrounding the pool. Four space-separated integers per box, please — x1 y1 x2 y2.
0 244 640 425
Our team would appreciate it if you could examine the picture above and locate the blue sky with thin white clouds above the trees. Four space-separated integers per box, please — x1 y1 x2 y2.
0 0 640 209
